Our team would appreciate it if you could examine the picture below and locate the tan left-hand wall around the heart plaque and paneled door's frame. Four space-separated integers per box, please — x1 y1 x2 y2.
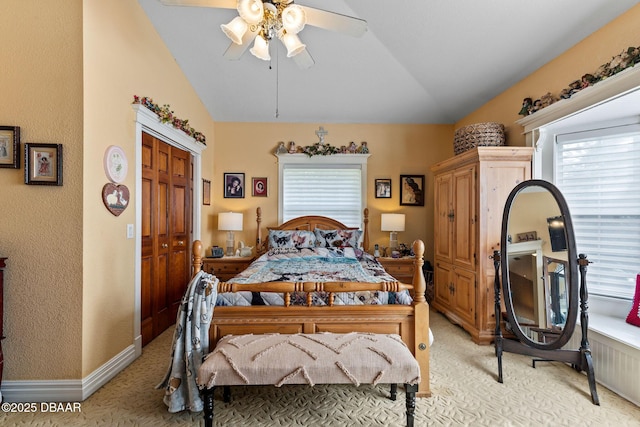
0 0 214 380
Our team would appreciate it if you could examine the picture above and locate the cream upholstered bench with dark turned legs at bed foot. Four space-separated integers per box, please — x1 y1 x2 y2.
197 332 420 426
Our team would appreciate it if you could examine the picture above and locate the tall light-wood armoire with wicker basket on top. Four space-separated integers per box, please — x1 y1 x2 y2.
431 147 533 344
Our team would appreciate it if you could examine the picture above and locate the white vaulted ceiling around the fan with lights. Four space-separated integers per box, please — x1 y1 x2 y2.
138 0 638 123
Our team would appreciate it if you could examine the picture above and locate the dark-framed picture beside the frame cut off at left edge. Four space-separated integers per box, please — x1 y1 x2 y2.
24 143 62 185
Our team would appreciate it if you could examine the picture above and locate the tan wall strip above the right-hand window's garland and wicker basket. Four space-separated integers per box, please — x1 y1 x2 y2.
455 5 640 146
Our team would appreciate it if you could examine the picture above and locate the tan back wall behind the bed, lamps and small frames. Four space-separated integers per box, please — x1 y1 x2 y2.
210 123 453 259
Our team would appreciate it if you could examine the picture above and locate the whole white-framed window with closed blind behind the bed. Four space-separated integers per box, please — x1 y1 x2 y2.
278 154 368 227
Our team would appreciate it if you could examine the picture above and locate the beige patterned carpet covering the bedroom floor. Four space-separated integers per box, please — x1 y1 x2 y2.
0 314 640 426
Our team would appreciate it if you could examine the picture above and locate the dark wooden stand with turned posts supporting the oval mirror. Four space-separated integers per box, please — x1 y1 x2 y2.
492 251 600 405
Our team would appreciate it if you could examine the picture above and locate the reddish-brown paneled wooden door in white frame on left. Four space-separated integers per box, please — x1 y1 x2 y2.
140 133 192 345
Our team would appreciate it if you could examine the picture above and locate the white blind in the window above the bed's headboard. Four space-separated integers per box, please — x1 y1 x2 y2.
282 165 362 227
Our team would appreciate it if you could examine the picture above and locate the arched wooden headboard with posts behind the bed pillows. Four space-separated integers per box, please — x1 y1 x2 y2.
256 208 369 253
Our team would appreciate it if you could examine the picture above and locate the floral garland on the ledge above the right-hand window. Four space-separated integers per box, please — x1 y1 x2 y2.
518 46 640 116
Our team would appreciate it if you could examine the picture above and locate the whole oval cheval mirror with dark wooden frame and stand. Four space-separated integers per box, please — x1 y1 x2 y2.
493 180 600 405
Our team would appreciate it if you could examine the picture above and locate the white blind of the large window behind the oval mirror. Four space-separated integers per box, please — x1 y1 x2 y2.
555 125 640 299
